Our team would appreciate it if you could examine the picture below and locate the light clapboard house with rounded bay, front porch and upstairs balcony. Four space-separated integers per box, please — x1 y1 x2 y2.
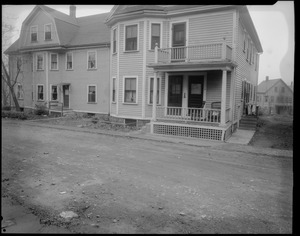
106 5 262 140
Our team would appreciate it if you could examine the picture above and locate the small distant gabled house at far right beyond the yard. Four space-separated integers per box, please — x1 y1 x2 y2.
257 76 293 114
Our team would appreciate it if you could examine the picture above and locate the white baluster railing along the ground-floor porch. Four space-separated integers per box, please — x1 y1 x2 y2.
156 106 223 123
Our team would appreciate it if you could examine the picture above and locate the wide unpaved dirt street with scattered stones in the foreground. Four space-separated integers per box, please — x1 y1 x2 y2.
2 120 293 233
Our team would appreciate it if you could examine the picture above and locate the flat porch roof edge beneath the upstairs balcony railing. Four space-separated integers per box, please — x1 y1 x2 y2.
147 61 237 71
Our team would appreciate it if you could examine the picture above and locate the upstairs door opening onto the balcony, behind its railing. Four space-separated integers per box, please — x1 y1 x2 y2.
171 22 186 61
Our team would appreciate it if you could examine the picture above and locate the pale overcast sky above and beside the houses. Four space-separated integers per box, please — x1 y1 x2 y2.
2 1 295 85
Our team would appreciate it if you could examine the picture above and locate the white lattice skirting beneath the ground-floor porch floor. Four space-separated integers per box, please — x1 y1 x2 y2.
153 123 230 141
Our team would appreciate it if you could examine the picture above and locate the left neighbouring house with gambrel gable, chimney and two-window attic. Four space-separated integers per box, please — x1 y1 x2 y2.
5 5 110 114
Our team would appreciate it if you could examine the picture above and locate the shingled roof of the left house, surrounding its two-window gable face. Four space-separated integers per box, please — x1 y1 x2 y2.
4 5 110 54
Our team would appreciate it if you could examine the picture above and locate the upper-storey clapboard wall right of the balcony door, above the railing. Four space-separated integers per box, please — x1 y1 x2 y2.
188 11 233 46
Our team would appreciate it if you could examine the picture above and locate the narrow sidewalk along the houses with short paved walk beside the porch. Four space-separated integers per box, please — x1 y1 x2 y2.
9 120 293 157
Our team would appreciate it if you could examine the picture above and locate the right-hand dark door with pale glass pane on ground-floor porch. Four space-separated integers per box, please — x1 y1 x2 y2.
188 75 204 108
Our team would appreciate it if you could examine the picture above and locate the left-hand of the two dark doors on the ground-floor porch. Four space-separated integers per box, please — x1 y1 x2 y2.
168 75 183 115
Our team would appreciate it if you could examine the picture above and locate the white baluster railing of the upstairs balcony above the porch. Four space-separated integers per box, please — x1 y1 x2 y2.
155 42 232 63
